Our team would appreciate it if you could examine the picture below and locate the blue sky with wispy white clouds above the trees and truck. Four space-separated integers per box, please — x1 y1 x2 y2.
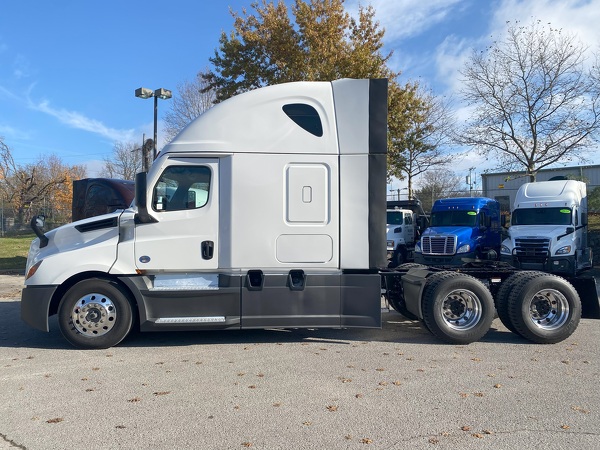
0 0 600 183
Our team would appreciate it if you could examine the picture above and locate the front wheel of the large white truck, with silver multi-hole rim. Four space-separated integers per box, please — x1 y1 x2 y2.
58 278 133 349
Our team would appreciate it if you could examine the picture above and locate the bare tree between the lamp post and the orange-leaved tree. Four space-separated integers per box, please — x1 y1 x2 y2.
164 71 215 142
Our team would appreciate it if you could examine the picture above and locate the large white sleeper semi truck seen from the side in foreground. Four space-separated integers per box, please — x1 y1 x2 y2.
21 79 600 348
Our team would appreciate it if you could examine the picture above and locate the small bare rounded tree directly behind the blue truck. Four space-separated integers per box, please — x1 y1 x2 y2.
415 167 468 211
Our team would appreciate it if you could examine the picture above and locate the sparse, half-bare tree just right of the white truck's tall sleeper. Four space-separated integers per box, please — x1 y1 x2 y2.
389 84 454 198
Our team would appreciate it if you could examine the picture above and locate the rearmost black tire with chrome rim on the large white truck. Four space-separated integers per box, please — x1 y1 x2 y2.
508 273 581 344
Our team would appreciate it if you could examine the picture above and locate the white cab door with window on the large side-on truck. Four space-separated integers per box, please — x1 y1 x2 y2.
135 158 219 271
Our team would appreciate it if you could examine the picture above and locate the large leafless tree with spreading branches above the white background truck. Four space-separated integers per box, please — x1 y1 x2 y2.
459 21 600 181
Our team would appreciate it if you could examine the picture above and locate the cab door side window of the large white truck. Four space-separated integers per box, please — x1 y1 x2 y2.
152 166 211 211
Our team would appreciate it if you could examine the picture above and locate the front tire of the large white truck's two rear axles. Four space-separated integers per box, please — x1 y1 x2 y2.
422 272 494 344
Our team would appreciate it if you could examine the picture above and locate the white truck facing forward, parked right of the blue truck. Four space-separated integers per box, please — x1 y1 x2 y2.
500 180 592 276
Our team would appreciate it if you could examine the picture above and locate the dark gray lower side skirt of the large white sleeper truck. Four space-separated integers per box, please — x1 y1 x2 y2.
121 270 381 331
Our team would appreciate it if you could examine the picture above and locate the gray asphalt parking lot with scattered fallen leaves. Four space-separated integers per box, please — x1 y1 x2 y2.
0 275 600 450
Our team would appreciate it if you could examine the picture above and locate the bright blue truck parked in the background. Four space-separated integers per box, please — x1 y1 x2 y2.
415 197 502 266
